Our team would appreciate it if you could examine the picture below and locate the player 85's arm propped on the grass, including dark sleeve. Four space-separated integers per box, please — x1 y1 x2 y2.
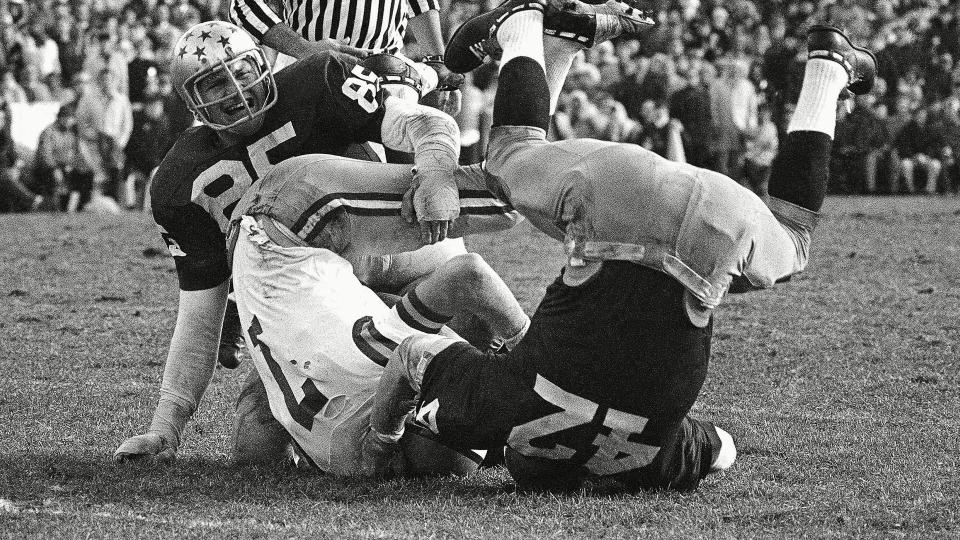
114 205 229 462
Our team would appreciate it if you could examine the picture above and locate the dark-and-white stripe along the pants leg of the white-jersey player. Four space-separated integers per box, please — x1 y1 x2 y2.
290 189 513 243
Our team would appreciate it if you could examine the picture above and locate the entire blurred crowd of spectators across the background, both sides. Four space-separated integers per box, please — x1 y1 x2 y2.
0 0 960 211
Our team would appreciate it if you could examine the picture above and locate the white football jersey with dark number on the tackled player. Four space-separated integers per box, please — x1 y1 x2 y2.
233 216 452 476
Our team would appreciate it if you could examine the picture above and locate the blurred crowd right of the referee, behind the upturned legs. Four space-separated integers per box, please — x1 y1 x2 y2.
446 0 960 195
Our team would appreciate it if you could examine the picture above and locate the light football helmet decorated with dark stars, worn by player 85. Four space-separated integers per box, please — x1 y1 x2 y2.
170 21 277 130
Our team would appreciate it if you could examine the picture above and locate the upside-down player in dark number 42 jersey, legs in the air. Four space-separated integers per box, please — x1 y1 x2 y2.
363 0 876 490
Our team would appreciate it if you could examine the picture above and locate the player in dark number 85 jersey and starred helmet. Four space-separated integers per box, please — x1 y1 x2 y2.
115 21 460 461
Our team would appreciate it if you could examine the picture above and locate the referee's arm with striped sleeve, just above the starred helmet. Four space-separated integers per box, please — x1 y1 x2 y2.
230 0 372 60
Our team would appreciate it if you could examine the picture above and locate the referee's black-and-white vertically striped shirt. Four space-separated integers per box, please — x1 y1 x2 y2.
230 0 439 53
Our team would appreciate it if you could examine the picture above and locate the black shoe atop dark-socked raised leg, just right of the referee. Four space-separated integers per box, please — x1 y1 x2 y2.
443 0 546 73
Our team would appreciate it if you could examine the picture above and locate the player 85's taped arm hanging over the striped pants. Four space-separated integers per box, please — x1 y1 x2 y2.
380 96 460 243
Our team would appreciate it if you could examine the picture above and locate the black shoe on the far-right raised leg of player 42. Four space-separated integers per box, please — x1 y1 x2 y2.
807 24 877 95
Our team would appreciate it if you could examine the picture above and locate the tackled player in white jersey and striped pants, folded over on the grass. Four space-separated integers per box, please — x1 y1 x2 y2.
228 155 529 476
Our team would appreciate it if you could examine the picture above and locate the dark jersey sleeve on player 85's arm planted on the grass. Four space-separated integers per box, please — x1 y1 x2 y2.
153 203 230 291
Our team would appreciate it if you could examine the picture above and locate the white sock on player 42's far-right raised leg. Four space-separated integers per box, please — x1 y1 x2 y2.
787 58 849 139
